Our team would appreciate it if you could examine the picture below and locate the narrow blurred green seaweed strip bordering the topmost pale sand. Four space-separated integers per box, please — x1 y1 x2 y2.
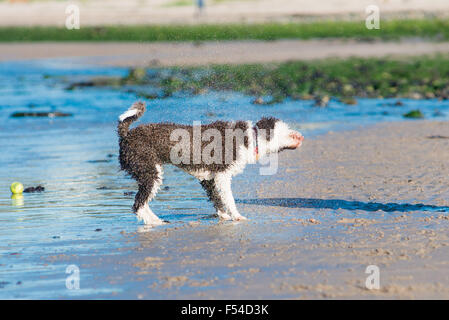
0 18 449 42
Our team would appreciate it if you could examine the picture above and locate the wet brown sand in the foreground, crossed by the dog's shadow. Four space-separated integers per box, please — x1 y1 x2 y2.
43 121 449 299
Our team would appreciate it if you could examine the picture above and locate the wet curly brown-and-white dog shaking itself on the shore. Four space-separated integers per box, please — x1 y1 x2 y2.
118 102 304 225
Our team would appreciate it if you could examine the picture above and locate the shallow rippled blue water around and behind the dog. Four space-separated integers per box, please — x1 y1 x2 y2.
0 60 449 298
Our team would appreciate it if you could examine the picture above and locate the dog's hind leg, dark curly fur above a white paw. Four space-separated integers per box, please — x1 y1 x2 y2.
133 165 164 226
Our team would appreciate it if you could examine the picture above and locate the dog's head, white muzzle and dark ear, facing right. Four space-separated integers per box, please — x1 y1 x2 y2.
256 117 304 154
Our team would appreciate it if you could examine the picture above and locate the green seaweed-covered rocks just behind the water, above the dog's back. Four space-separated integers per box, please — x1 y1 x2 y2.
153 55 449 99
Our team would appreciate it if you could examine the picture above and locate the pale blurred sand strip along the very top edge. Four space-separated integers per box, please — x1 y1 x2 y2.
0 0 449 27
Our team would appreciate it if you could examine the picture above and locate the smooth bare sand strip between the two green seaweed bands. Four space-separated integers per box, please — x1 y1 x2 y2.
0 39 449 67
